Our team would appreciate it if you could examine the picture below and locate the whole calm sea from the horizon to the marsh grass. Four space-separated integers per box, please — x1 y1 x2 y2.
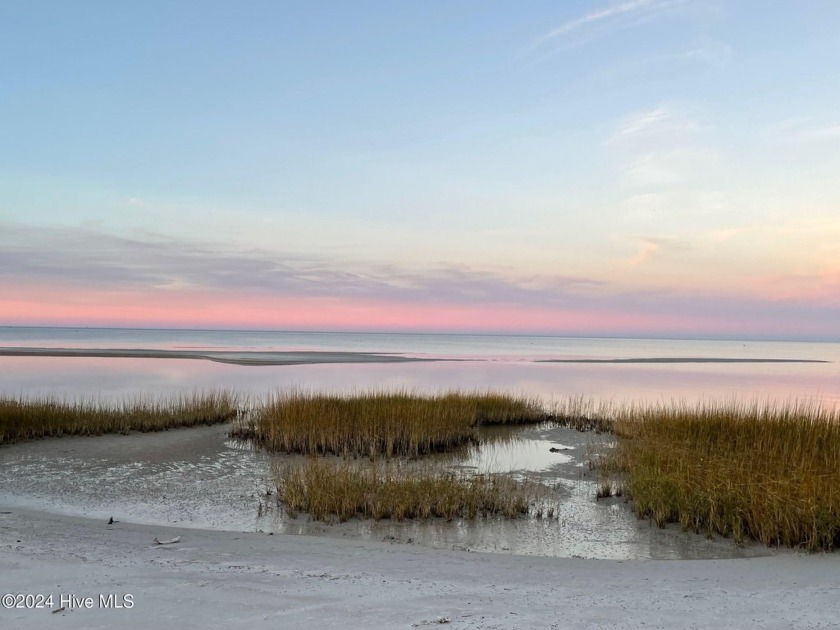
0 327 840 404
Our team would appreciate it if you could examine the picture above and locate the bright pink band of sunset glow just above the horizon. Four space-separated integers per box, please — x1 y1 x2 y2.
1 285 830 336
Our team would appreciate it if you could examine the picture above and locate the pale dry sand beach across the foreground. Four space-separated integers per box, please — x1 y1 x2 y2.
0 507 840 630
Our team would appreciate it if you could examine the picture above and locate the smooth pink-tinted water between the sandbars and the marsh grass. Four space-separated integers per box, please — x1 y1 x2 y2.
0 357 840 403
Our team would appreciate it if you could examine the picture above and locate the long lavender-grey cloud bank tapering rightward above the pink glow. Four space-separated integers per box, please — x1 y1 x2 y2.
0 224 601 304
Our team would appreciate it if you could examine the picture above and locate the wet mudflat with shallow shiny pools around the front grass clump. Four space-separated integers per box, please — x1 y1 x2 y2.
0 425 771 559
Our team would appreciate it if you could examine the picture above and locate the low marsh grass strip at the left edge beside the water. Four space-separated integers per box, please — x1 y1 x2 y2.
0 391 237 444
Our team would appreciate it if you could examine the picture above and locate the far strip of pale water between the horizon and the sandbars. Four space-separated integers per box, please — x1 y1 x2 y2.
0 326 840 362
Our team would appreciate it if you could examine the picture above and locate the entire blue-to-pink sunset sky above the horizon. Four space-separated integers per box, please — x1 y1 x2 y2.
0 0 840 340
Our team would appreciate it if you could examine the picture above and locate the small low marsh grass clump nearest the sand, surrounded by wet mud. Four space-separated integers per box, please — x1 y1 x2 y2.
275 457 529 522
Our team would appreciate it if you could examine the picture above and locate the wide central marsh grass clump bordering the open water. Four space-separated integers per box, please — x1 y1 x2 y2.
232 391 547 459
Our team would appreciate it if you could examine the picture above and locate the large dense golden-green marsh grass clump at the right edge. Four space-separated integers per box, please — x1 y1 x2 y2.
605 403 840 551
